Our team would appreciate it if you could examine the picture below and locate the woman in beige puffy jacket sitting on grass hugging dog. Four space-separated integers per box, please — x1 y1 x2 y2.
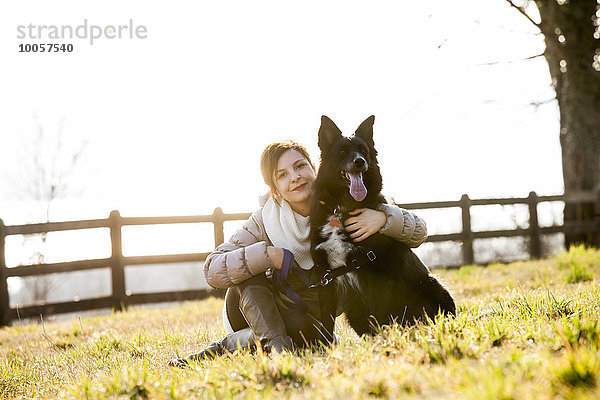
169 141 427 366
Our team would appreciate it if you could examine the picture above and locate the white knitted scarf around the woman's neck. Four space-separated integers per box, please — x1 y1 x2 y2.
263 197 314 270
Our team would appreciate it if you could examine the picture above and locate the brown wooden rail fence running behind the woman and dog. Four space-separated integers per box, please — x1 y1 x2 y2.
0 192 600 325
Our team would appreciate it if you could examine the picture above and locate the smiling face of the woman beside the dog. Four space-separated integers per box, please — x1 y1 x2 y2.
273 149 316 215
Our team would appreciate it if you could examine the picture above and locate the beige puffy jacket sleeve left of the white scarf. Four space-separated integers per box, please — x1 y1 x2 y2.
204 210 273 289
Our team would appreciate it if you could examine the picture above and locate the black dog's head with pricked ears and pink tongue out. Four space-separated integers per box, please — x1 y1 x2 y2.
319 115 381 203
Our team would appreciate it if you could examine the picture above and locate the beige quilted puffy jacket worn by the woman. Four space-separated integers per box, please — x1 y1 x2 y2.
204 204 427 289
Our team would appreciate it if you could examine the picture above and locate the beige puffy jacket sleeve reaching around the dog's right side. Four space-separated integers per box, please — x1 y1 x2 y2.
377 204 427 247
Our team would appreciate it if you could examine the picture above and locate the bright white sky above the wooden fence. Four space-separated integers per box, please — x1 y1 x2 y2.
0 0 563 224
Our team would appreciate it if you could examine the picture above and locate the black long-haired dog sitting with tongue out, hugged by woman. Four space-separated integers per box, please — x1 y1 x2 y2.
310 116 456 335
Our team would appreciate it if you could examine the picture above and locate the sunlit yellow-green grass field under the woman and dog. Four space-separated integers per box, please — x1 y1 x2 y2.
0 247 600 400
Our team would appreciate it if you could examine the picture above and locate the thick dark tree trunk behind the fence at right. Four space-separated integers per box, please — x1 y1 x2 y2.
536 0 600 248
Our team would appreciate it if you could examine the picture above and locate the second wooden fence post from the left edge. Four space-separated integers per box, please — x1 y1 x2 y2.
108 210 127 311
